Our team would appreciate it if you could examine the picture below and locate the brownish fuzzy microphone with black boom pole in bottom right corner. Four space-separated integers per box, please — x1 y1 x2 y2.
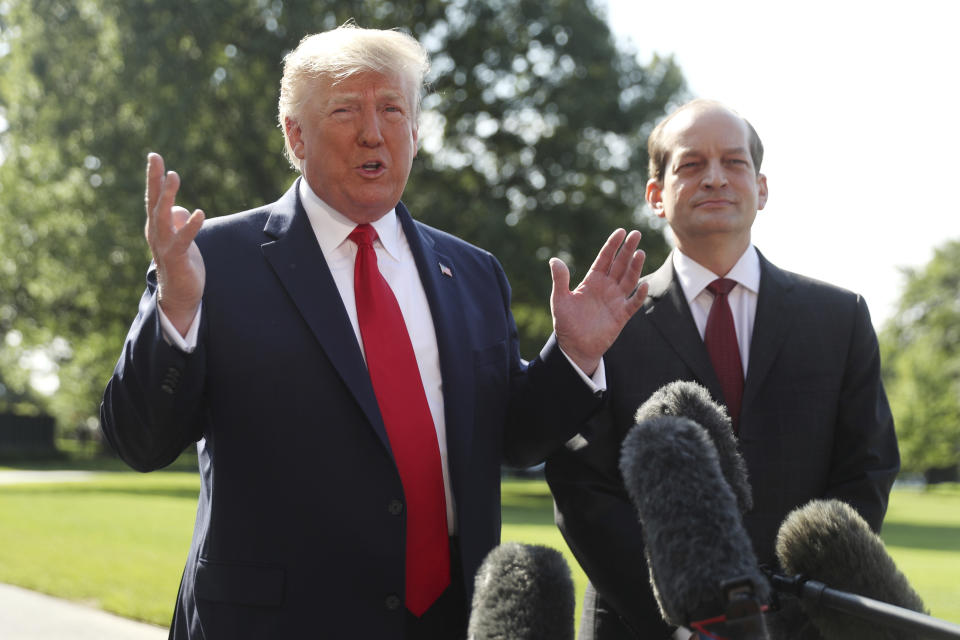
772 500 960 640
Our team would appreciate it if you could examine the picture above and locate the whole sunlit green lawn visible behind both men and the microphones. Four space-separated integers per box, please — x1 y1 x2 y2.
0 472 960 625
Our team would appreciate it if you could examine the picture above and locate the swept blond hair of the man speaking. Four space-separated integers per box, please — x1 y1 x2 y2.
278 22 430 169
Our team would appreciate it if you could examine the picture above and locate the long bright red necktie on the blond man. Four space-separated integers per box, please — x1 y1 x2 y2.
350 224 450 616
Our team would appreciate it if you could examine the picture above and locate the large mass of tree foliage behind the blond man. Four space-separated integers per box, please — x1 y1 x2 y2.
0 0 684 427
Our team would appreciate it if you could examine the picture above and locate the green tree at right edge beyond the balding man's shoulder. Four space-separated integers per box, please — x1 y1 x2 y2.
881 240 960 472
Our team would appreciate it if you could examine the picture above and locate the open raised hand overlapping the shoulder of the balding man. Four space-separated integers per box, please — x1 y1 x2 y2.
550 229 648 375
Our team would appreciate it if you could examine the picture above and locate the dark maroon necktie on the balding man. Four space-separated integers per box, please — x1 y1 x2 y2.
703 278 743 431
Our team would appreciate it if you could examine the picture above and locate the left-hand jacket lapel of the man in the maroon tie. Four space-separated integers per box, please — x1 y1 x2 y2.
641 257 723 398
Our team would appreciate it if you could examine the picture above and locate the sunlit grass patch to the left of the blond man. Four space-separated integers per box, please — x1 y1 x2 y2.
0 473 199 625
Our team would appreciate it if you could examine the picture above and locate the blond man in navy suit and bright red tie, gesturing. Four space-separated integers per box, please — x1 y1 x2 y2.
101 25 645 640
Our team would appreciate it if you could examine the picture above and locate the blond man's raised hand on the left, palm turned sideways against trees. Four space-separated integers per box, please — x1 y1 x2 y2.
144 153 206 335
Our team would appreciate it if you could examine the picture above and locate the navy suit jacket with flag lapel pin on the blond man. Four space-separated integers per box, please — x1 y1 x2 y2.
101 184 600 640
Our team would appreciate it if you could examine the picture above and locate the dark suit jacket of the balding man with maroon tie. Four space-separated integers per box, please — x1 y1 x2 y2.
546 255 900 640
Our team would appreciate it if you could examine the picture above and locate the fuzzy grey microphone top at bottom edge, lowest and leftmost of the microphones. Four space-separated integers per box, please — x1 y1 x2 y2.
467 542 575 640
